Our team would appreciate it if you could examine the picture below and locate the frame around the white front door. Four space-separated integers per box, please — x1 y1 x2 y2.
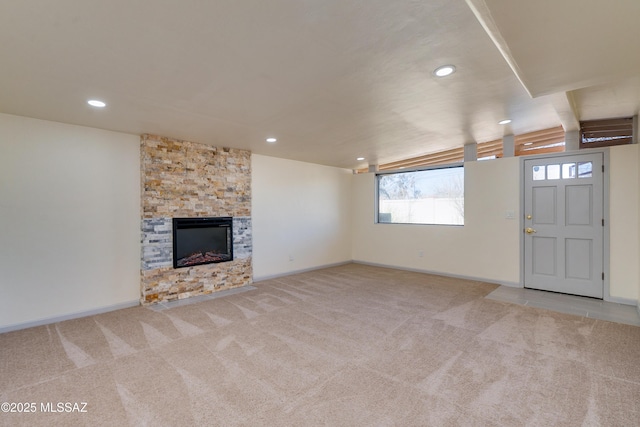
518 147 615 302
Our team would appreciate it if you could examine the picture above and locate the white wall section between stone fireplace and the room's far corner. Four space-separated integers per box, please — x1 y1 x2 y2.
251 154 352 280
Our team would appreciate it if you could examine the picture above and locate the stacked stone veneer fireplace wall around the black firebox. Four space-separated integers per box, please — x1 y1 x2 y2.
140 135 253 304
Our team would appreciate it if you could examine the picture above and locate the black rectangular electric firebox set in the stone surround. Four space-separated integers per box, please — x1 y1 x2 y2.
173 217 233 268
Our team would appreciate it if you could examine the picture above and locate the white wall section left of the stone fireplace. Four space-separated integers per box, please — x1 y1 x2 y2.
0 114 140 330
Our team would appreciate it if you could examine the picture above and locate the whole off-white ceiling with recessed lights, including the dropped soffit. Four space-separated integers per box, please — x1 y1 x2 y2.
0 0 640 168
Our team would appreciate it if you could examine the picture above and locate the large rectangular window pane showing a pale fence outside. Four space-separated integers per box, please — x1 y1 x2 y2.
377 166 464 225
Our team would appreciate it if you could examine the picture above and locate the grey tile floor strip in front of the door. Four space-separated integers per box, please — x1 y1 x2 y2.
485 286 640 326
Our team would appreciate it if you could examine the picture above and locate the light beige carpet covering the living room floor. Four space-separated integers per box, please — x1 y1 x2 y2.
0 264 640 426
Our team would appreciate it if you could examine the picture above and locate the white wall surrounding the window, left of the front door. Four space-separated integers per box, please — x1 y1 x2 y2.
352 158 520 285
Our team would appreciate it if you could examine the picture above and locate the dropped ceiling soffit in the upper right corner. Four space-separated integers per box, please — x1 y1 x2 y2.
466 0 640 97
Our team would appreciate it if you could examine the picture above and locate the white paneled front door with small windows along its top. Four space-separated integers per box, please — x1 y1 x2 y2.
523 153 604 298
